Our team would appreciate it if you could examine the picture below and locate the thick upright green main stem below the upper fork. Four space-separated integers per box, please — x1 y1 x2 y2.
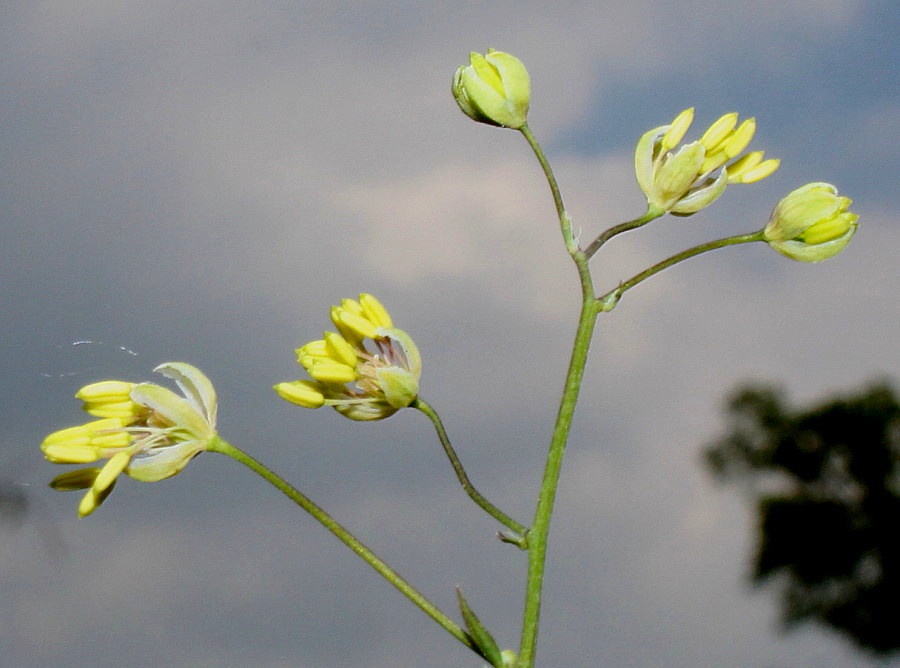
516 288 599 668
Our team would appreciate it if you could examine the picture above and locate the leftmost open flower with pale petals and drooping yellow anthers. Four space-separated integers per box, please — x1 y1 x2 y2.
41 362 218 517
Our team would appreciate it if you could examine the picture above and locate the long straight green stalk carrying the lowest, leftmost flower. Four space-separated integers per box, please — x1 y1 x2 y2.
207 438 479 653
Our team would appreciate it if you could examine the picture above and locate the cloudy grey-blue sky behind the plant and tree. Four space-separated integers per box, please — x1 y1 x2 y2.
0 0 900 668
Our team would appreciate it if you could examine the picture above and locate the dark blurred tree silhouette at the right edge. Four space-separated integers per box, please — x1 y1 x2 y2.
705 382 900 655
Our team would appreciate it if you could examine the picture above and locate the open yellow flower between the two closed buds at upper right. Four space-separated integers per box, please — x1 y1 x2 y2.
634 109 779 216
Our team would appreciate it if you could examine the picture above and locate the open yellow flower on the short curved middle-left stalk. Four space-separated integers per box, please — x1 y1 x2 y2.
275 294 422 420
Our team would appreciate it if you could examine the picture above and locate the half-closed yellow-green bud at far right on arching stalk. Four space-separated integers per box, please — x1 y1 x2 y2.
763 183 859 262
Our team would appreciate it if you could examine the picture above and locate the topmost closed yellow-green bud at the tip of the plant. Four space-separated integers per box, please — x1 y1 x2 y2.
452 49 531 129
